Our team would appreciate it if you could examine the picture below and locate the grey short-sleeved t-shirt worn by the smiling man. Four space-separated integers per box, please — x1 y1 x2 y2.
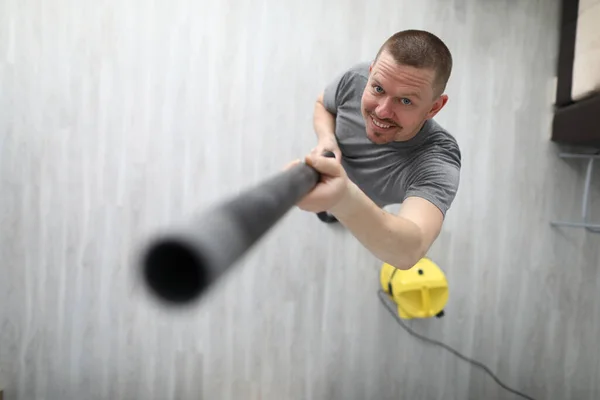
324 62 461 216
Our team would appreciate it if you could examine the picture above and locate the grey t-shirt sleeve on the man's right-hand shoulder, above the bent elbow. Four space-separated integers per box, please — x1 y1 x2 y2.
404 143 461 217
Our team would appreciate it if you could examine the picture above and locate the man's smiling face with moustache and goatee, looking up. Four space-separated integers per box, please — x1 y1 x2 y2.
362 52 448 144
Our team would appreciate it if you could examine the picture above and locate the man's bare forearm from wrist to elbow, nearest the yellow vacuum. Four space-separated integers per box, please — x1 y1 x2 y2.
329 182 425 269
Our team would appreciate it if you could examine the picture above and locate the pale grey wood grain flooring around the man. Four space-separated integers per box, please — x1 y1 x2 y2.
0 0 600 400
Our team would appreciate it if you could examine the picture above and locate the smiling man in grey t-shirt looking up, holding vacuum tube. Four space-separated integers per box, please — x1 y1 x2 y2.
298 30 461 269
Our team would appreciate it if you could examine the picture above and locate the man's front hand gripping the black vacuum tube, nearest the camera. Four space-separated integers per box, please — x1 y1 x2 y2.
297 152 349 213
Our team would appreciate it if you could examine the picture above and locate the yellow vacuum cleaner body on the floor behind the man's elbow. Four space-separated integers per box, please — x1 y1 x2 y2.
379 257 448 319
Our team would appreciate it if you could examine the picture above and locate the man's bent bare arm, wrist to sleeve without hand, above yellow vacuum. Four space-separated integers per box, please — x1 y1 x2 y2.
329 181 444 269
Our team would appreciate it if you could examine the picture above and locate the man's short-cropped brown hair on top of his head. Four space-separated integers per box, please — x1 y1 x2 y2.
375 29 452 96
